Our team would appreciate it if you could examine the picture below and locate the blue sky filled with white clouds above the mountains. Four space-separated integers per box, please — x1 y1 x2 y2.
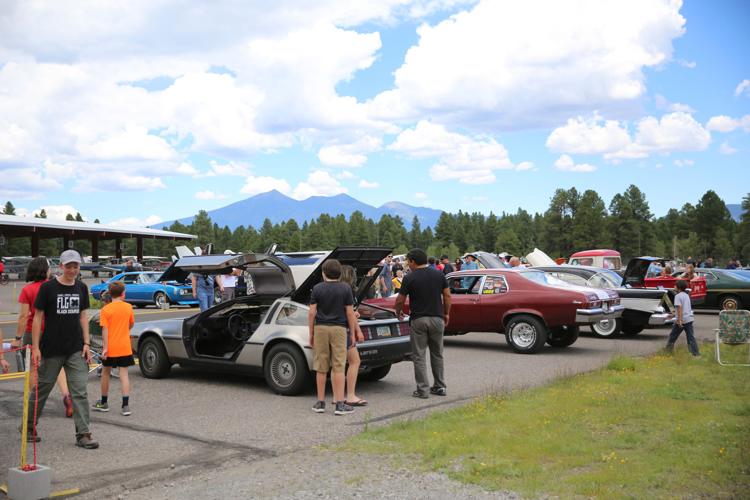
0 0 750 225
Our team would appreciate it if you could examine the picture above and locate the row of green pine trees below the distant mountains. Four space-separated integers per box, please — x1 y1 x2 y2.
0 185 750 262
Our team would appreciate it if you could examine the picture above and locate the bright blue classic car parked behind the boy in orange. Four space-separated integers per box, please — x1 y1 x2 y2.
91 271 198 307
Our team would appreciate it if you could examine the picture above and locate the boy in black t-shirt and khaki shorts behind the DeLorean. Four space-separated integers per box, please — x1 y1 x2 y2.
307 259 357 415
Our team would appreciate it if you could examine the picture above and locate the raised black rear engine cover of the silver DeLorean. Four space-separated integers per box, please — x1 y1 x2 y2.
290 247 393 304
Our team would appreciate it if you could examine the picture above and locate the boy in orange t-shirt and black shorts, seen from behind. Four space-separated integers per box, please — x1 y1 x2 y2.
93 281 135 416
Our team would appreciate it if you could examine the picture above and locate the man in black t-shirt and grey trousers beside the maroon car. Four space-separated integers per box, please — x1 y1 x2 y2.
396 248 451 399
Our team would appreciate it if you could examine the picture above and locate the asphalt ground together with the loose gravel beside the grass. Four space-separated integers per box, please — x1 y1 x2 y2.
0 290 718 499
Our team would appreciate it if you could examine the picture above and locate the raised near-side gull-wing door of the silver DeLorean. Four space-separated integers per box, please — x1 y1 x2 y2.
159 253 294 296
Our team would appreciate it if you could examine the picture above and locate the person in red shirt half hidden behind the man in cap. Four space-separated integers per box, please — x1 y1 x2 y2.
13 257 73 418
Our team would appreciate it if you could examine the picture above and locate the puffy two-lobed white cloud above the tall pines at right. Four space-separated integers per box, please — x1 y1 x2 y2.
547 112 711 160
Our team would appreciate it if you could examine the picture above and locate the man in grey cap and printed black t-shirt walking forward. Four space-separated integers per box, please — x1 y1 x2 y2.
26 250 99 449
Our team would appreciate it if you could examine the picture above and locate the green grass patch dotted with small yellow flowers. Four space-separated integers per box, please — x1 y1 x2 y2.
347 344 750 498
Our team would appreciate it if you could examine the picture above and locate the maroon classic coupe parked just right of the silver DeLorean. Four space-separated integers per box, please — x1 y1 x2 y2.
368 269 623 354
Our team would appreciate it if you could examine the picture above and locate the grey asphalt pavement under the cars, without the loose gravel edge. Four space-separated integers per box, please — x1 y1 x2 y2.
0 296 717 497
